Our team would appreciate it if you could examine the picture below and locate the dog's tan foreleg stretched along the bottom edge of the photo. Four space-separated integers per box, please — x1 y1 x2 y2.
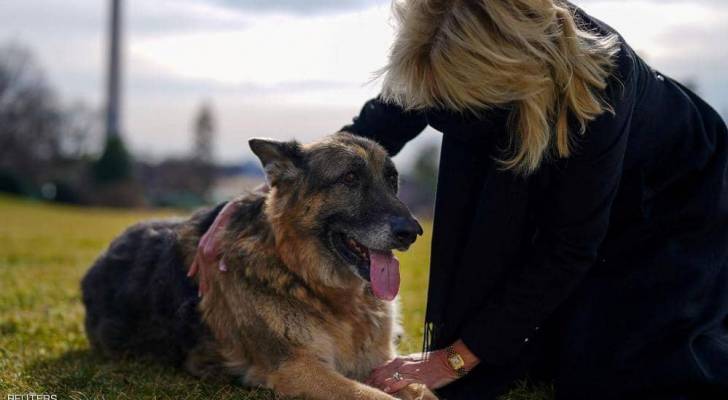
268 354 396 400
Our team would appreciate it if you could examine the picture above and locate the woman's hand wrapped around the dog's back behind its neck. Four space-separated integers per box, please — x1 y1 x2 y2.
187 185 268 297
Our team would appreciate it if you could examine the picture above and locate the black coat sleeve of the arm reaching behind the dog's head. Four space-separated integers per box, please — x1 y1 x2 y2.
341 97 427 156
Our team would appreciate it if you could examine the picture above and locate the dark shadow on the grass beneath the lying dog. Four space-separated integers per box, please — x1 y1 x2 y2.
24 350 276 400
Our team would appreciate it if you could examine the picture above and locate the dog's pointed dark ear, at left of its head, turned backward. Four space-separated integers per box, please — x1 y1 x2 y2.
248 138 303 186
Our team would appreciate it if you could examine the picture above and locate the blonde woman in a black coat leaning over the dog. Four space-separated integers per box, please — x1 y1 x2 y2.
192 0 728 399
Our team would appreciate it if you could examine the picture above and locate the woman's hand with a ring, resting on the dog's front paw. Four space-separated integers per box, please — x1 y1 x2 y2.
366 350 458 393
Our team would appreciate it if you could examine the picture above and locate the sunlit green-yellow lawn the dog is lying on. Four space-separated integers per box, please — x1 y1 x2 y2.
0 196 547 400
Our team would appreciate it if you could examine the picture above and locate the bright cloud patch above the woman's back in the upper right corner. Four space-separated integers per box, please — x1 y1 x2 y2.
575 0 728 113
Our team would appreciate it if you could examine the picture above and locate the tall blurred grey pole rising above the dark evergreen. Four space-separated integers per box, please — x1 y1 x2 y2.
106 0 121 140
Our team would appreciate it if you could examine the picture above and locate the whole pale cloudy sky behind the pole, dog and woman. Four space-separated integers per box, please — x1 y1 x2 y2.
0 0 728 165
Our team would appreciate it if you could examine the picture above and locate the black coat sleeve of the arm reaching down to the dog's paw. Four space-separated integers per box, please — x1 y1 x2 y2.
460 70 635 365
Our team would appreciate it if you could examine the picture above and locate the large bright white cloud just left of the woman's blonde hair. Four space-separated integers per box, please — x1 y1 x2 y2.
129 7 392 85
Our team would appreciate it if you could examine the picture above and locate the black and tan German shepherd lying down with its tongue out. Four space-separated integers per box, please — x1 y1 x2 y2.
81 132 434 400
